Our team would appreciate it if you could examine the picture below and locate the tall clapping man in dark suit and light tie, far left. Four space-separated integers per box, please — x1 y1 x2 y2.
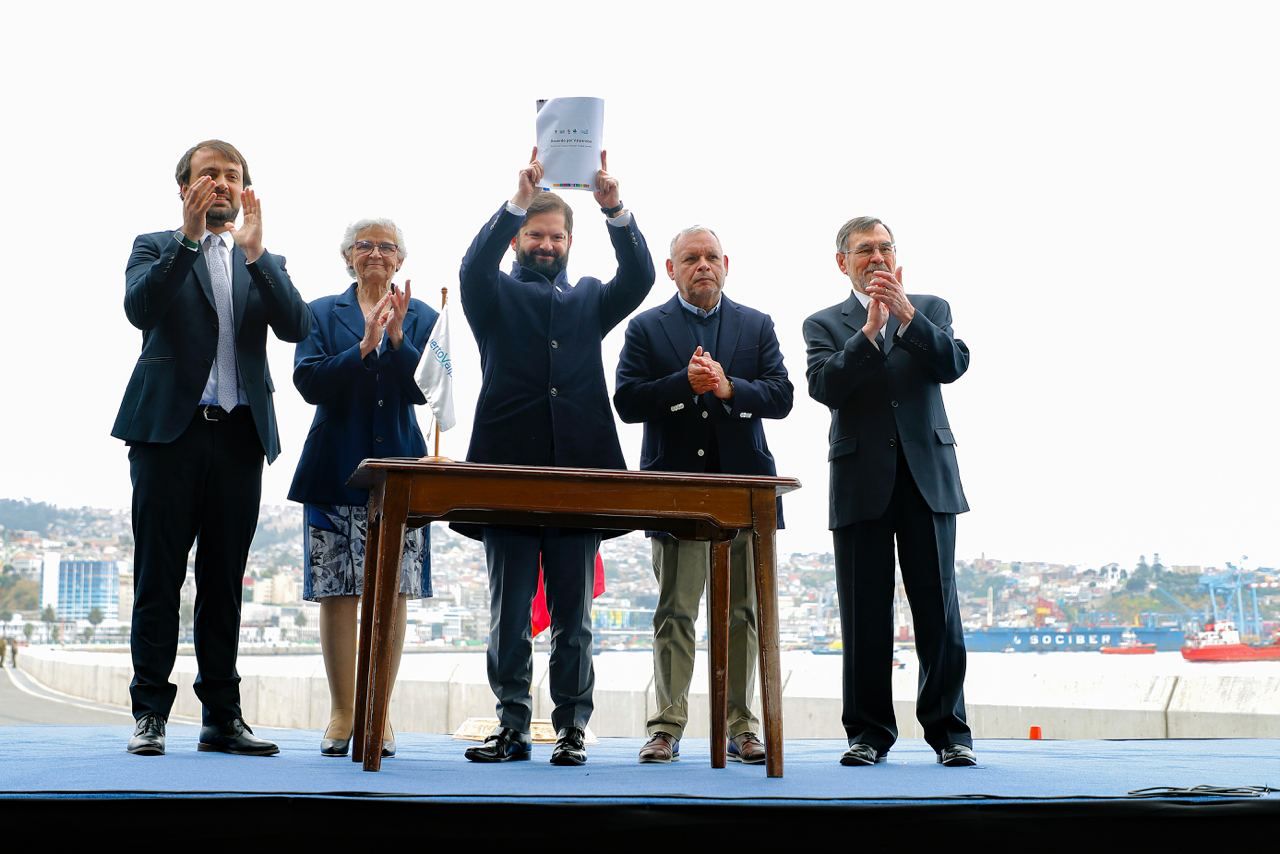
111 140 311 755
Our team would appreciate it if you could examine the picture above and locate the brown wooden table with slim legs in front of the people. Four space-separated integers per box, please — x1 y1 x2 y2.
349 460 800 777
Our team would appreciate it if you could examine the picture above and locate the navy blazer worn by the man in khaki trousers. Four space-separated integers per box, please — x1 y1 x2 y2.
613 296 792 528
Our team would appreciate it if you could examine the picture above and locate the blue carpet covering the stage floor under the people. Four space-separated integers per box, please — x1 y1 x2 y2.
0 725 1280 805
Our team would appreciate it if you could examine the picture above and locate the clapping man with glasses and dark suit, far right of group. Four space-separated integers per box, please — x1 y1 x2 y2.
804 216 975 767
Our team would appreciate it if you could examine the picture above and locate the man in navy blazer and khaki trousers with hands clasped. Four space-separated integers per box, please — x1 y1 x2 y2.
613 225 792 764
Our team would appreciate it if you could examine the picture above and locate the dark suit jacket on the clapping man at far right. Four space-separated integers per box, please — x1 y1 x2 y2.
804 292 969 529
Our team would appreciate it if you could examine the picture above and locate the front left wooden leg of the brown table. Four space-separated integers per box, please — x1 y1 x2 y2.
364 474 410 771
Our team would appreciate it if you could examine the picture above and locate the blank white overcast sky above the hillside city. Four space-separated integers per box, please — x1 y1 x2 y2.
0 0 1280 566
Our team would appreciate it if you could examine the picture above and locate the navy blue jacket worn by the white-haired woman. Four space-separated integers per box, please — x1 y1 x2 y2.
289 284 439 506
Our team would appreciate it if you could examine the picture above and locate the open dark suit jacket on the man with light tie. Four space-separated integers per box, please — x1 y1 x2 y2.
111 232 311 462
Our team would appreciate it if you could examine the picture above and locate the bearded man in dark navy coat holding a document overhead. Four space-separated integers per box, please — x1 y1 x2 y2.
456 149 654 766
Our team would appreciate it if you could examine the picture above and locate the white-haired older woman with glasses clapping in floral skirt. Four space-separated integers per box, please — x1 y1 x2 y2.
289 219 436 757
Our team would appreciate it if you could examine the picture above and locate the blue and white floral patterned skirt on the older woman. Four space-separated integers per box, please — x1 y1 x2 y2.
302 504 431 602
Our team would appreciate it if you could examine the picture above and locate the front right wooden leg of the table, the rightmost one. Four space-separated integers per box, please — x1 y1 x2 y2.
751 489 782 777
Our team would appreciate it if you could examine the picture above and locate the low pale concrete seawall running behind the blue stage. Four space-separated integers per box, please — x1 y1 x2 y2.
19 647 1280 739
